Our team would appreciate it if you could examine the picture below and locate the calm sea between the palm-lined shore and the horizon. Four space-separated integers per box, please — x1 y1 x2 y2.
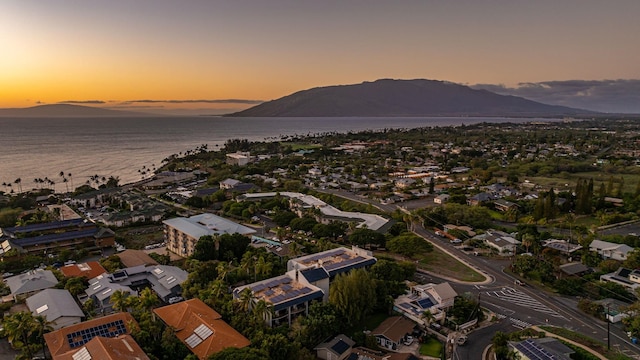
0 117 552 191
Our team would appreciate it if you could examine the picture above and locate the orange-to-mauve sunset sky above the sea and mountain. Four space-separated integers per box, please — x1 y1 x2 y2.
0 0 640 111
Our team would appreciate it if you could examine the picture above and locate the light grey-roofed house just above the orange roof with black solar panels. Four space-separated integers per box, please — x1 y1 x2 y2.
27 289 84 330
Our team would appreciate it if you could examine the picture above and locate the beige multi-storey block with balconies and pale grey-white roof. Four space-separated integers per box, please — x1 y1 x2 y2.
162 213 256 257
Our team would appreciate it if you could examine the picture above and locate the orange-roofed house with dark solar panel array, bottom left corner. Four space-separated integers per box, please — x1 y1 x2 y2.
44 312 149 360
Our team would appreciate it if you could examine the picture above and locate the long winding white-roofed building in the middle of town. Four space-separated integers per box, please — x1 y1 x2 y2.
236 191 391 232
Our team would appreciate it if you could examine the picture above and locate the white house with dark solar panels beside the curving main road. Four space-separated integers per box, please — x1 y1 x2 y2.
393 282 458 326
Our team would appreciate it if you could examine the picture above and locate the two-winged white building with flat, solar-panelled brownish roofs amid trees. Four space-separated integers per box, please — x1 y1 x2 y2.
233 247 377 326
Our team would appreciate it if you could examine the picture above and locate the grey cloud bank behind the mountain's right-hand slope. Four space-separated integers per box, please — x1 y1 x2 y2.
471 79 640 114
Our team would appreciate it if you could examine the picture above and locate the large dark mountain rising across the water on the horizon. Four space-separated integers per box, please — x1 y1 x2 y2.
228 79 597 117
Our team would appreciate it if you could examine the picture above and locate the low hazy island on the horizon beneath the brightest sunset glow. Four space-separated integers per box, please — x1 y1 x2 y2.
0 104 151 117
